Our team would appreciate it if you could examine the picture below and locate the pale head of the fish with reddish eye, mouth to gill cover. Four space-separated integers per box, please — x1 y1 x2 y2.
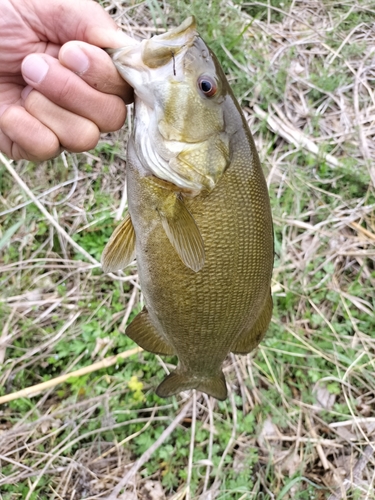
111 17 230 194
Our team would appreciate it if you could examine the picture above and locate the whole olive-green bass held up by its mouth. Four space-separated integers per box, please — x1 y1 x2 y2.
101 16 274 400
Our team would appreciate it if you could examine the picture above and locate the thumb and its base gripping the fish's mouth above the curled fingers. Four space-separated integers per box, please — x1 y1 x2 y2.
29 0 134 48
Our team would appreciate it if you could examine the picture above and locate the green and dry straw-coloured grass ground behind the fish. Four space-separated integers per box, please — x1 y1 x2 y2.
0 0 375 500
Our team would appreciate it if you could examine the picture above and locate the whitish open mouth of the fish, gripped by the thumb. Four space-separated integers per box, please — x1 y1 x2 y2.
107 16 199 90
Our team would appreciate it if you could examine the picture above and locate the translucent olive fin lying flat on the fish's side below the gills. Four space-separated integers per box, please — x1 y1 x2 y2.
158 194 204 272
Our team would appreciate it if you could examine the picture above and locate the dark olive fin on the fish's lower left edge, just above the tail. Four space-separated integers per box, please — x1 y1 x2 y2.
125 307 175 355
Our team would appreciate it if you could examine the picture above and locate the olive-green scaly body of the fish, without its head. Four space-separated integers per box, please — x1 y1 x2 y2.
104 17 273 399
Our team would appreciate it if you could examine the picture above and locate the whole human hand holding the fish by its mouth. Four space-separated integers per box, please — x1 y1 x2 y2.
0 0 134 161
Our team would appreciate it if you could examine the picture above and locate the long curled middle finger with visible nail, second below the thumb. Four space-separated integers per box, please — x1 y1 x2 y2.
22 54 126 132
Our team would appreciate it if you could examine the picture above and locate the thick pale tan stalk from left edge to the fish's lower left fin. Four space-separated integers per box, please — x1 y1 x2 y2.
0 347 143 404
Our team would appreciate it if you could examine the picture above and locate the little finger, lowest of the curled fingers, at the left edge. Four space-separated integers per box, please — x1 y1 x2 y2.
0 106 60 161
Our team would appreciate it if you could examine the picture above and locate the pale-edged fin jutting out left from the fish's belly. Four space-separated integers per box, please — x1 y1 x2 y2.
101 214 135 273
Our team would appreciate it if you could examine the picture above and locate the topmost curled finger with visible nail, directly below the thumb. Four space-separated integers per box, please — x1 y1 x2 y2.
59 42 133 104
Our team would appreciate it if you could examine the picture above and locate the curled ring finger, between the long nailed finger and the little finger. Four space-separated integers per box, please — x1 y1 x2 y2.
25 90 100 153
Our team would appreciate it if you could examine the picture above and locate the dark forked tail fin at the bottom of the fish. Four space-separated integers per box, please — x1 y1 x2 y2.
156 368 227 401
